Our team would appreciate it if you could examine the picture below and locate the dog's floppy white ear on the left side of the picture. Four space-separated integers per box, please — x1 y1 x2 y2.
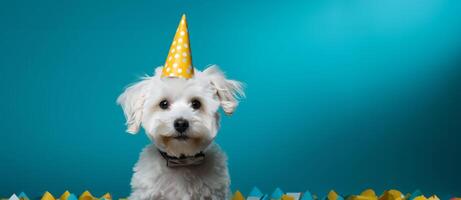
117 78 151 134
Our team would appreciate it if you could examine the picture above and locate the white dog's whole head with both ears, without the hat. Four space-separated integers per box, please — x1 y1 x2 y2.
117 66 243 156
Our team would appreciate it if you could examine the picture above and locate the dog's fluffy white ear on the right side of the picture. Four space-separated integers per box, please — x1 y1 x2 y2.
203 65 245 115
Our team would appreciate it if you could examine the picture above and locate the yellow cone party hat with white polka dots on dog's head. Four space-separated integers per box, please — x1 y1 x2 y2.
162 15 194 79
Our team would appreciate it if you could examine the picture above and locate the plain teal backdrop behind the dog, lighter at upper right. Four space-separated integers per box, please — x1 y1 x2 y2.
0 0 461 198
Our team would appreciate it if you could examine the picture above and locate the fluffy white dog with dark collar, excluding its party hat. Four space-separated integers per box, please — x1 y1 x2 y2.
117 66 244 200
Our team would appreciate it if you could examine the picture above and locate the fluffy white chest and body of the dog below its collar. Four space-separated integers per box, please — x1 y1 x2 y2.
130 147 230 200
